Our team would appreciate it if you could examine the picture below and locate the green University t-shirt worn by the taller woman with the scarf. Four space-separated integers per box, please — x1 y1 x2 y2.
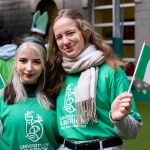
57 64 141 142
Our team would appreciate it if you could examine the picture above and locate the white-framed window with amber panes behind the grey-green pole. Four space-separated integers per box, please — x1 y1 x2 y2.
92 0 135 61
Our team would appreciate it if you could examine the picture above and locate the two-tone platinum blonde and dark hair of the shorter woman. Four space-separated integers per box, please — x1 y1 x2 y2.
4 41 53 109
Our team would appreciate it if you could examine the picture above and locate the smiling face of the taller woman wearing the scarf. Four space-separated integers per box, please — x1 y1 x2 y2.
53 17 85 58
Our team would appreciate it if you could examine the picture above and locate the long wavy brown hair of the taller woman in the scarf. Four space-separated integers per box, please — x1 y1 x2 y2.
46 9 126 95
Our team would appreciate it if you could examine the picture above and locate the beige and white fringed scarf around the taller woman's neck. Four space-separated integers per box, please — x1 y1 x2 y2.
62 44 104 125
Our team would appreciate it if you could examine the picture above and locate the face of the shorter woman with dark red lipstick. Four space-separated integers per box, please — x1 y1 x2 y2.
15 48 43 84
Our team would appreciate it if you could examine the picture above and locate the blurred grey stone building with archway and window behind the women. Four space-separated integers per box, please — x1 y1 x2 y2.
0 0 146 61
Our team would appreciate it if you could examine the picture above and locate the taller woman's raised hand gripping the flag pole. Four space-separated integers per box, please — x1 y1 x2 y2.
110 92 132 121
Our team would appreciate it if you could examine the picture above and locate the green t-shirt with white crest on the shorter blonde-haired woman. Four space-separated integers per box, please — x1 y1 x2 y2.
0 98 59 150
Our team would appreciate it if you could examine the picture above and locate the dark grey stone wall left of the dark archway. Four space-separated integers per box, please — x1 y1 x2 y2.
0 0 32 34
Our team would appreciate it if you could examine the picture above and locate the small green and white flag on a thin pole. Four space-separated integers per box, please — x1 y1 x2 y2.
128 42 150 93
